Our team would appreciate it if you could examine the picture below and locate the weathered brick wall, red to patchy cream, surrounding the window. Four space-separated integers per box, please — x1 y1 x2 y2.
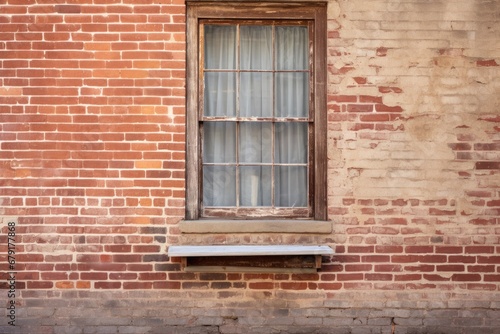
0 0 500 333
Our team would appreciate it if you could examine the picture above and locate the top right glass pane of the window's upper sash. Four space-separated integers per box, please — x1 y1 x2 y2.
276 26 309 71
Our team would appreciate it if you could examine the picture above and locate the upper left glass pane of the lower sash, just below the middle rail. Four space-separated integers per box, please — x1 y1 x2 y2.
203 122 236 163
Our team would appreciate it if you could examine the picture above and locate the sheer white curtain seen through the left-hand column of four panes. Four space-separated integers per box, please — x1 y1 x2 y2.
203 26 236 206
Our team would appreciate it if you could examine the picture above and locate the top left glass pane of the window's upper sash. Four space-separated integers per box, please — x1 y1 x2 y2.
205 25 236 69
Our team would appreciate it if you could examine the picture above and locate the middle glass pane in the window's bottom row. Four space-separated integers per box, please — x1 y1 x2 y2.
240 166 271 206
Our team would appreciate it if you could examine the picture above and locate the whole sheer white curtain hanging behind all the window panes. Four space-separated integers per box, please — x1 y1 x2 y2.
202 25 309 207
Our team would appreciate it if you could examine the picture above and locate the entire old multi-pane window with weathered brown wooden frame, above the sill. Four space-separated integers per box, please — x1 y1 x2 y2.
186 1 326 220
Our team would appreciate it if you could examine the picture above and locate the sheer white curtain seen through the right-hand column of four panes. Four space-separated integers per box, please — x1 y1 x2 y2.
274 26 309 207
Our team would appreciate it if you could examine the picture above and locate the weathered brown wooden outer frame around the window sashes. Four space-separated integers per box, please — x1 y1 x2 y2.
186 1 327 221
